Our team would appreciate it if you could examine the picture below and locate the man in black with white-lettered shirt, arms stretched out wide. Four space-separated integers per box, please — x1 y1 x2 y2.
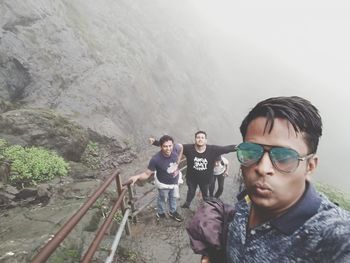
150 131 235 208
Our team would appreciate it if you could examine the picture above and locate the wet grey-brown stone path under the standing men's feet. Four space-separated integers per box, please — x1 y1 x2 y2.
120 154 241 263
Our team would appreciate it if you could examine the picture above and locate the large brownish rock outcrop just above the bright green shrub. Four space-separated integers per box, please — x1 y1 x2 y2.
0 109 89 161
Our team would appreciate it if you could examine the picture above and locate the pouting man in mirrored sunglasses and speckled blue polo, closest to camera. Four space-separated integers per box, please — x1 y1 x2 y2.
227 97 350 263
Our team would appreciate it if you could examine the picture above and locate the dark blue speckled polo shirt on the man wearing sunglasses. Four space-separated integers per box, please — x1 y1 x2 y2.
227 184 350 263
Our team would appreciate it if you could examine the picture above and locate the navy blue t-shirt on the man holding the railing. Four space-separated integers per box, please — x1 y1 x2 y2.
148 144 180 184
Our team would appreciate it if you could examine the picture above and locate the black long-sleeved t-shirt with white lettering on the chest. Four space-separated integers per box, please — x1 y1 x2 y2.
183 144 235 183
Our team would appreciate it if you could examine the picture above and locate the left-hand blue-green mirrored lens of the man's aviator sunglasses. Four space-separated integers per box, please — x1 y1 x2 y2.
237 142 264 166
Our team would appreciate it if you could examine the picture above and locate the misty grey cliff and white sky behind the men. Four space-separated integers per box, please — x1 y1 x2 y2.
0 0 350 193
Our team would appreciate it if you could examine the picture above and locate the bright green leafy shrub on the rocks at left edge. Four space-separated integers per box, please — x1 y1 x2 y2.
0 139 69 184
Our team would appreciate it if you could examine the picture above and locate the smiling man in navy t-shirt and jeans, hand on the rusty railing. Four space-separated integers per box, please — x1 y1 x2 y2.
129 135 183 222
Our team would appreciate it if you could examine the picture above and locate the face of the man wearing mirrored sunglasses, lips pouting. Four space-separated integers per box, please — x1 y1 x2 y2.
241 117 317 214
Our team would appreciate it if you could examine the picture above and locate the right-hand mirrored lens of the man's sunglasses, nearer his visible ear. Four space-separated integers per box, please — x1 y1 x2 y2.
270 147 299 173
